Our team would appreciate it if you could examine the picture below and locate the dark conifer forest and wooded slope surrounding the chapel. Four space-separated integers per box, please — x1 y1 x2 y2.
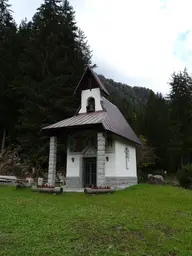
0 0 192 180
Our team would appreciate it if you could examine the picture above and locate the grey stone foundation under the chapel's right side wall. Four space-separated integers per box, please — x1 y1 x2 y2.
105 177 138 188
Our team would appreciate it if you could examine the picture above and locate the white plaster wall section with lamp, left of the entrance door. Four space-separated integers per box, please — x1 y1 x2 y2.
66 151 82 177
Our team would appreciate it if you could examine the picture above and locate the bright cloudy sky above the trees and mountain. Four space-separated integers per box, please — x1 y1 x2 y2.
9 0 192 95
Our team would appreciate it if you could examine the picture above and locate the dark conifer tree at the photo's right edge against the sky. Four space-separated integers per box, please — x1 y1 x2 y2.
169 69 192 171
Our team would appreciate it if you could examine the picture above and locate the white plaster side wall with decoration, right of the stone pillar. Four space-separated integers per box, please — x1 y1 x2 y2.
115 139 137 177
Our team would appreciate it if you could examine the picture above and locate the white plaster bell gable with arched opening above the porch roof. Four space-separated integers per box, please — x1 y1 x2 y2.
79 88 103 114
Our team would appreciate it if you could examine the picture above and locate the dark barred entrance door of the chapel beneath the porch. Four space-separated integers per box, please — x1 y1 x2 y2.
83 157 97 187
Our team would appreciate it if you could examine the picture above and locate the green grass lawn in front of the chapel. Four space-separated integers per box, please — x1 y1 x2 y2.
0 185 192 256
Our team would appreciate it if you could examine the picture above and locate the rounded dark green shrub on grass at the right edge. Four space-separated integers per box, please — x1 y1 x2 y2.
177 164 192 188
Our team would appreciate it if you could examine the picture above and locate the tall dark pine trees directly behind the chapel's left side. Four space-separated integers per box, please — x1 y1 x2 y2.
15 0 91 167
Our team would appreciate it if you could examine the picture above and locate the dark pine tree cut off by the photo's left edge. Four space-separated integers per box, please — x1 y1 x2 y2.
0 0 18 150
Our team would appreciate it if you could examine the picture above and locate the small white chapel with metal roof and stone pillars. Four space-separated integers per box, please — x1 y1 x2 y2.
41 67 141 189
